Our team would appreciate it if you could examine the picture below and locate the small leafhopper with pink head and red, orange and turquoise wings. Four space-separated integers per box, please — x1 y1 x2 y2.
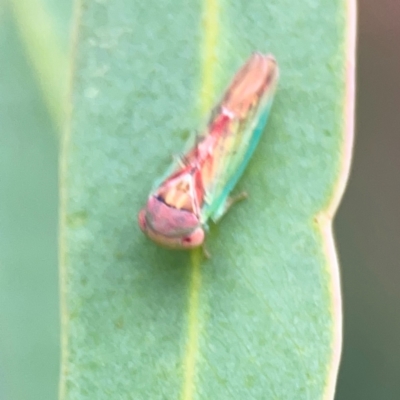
138 53 279 249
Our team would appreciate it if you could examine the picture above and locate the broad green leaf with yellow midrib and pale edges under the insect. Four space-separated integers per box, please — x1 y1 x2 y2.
61 0 355 400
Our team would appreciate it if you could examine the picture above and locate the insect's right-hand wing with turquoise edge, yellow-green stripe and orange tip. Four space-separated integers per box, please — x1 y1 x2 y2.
201 53 278 221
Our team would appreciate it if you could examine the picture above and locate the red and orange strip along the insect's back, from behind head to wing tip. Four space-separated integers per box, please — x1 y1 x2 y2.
157 53 278 215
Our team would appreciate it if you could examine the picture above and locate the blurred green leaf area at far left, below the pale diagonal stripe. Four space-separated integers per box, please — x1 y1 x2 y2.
0 10 60 400
